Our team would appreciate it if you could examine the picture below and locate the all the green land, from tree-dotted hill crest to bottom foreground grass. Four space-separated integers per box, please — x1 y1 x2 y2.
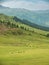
0 14 49 65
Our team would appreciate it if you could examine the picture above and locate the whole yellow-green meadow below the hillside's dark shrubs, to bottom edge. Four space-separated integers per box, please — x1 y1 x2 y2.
0 34 49 65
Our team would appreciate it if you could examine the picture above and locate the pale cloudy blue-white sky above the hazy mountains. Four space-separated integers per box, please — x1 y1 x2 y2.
0 0 49 10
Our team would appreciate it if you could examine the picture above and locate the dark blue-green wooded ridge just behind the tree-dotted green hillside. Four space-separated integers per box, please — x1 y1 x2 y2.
13 17 49 31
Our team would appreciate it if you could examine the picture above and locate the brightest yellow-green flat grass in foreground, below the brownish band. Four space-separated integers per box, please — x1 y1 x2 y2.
0 46 49 65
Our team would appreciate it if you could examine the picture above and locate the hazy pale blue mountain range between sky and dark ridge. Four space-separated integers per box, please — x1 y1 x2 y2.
0 5 49 27
